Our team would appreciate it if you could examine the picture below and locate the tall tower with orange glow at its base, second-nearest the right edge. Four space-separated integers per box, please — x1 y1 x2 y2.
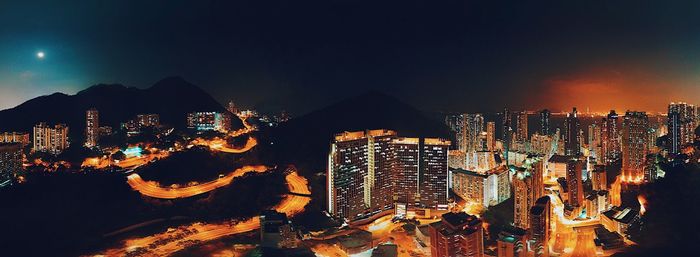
622 111 649 181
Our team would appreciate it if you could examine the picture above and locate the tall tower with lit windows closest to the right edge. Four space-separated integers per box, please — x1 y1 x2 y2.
668 103 697 154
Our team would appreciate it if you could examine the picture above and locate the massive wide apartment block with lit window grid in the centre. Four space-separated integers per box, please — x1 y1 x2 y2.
328 130 450 220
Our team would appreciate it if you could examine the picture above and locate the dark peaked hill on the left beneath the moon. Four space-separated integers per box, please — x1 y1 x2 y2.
0 77 243 142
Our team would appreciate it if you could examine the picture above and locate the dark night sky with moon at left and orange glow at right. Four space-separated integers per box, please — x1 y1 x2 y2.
0 0 700 113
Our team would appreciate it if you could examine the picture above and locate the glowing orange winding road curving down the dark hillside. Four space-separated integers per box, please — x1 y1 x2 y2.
95 115 311 256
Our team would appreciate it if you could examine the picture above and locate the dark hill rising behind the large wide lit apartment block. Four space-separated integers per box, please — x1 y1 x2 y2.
262 91 450 174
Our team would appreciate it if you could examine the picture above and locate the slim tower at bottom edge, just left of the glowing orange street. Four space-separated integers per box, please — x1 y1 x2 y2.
530 196 552 257
